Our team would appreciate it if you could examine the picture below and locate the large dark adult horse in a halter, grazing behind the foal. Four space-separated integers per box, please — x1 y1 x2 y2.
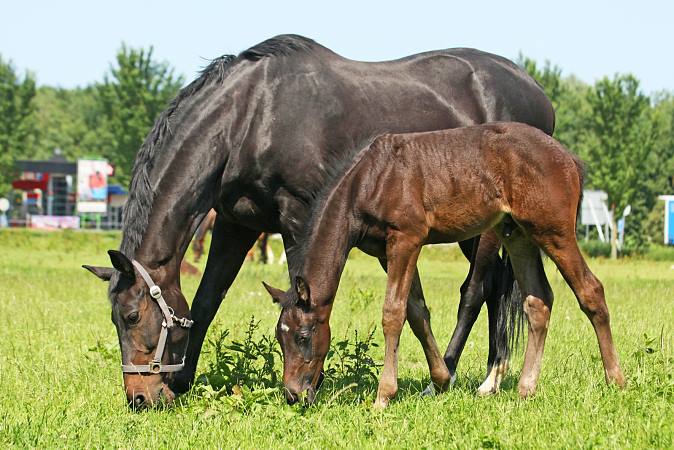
81 35 554 406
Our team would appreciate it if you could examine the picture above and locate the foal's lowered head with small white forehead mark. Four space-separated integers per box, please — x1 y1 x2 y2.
263 276 332 404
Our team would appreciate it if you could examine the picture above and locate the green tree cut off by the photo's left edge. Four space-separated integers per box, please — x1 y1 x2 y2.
0 56 35 194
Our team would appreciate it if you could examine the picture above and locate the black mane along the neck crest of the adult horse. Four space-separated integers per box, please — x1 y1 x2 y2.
120 34 318 258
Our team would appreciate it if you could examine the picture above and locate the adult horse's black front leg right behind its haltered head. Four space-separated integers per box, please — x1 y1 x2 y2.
172 216 260 393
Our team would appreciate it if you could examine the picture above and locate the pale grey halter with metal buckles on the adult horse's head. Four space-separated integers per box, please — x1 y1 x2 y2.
122 259 194 374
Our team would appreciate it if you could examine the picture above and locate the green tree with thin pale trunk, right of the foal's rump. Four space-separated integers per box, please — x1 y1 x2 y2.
582 75 657 258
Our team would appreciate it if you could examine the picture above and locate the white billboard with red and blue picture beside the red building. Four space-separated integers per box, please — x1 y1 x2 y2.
77 159 108 213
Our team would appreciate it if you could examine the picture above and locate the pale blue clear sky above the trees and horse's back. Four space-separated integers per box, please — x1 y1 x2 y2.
0 0 674 93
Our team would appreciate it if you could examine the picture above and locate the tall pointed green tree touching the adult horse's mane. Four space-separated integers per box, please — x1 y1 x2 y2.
97 45 183 185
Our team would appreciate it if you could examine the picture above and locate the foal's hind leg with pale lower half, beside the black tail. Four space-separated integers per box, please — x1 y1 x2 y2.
504 236 554 397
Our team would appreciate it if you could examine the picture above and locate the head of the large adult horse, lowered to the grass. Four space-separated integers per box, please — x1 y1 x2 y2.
83 250 189 408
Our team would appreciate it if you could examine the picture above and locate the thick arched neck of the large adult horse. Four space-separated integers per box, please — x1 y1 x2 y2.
121 58 252 272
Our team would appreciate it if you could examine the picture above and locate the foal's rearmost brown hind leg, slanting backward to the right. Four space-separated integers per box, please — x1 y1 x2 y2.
534 233 625 387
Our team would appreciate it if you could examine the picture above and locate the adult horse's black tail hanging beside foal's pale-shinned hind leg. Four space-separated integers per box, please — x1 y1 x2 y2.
496 247 526 360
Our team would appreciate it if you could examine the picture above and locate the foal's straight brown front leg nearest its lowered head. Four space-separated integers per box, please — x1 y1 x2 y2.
374 233 421 409
